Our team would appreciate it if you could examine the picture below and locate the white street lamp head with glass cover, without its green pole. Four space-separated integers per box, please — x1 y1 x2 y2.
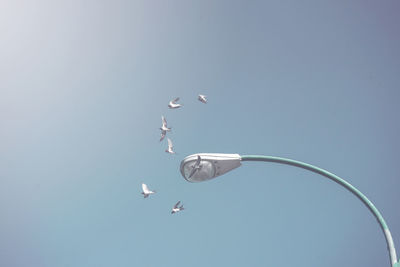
180 153 241 182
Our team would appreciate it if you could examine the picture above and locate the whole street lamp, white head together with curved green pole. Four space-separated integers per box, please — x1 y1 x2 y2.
180 153 400 267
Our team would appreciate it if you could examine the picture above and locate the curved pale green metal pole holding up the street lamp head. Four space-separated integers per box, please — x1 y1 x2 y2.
241 155 400 267
